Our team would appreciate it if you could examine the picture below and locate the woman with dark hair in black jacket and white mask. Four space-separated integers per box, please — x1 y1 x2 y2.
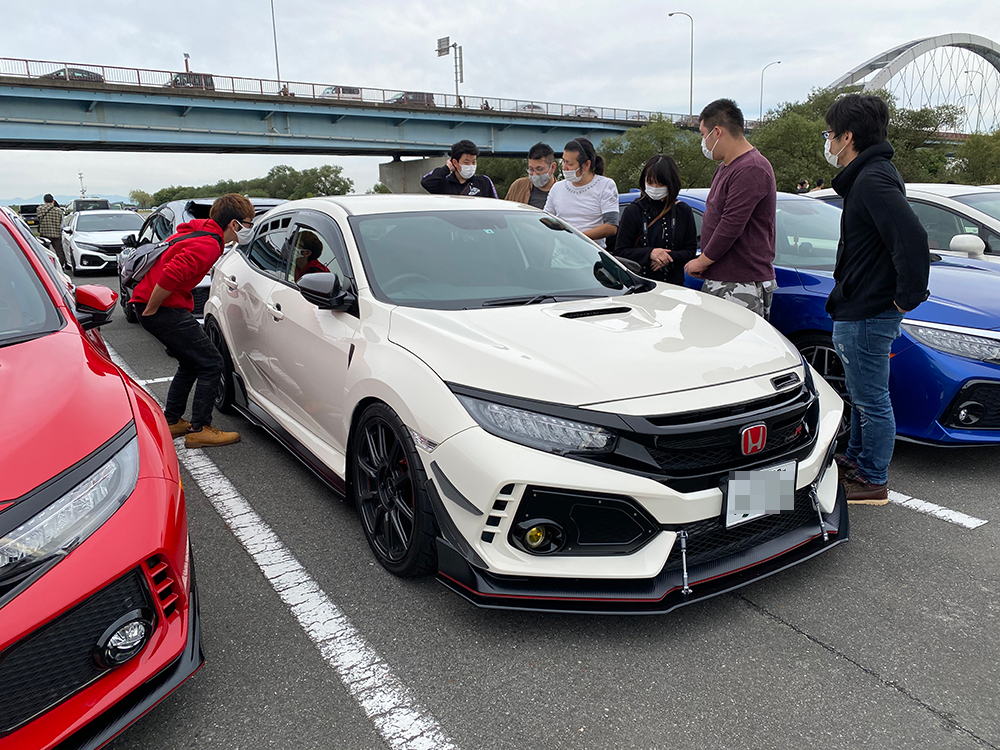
614 154 698 286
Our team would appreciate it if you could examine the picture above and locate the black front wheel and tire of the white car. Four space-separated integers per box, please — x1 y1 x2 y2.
351 403 437 578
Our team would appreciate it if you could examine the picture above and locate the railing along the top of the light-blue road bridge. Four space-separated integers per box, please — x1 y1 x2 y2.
0 58 698 127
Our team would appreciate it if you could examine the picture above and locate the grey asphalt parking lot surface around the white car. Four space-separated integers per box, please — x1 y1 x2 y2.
77 277 1000 750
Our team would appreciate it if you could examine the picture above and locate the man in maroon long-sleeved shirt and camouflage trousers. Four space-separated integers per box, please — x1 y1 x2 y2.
684 99 778 320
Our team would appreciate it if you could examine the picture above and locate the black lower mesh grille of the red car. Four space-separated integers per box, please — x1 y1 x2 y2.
0 570 151 735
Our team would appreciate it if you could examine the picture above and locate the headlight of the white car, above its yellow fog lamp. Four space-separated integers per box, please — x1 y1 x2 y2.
458 396 615 453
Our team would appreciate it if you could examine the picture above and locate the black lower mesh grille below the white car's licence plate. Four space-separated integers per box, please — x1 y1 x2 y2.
664 485 820 570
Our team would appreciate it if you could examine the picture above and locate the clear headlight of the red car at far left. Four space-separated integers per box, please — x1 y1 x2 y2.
0 437 139 580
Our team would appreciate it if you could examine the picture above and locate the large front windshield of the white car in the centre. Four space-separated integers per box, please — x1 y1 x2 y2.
350 210 640 310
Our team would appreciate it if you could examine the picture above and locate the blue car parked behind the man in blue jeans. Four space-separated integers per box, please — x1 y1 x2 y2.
619 189 1000 446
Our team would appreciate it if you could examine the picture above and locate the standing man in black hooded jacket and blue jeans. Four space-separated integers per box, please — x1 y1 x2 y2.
823 94 930 505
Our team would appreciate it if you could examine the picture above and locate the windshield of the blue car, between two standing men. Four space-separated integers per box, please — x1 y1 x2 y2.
774 198 841 271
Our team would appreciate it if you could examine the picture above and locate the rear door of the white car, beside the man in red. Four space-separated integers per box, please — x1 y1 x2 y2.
222 214 291 407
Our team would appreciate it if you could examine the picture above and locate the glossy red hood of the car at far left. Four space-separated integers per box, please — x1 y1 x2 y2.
0 328 132 502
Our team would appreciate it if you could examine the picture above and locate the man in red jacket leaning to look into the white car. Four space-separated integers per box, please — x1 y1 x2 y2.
129 193 254 448
